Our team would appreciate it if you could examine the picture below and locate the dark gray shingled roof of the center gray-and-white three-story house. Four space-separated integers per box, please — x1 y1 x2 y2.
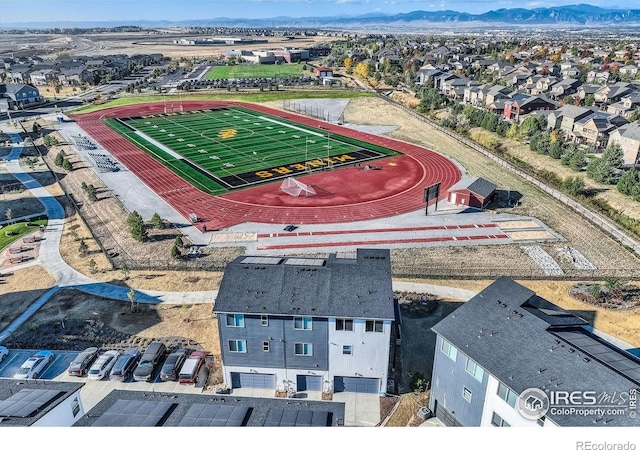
213 249 394 320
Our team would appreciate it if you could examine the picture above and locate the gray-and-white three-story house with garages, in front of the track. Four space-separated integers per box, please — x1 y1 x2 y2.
213 249 396 395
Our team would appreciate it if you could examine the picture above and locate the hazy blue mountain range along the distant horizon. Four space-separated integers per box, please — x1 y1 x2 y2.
0 4 640 30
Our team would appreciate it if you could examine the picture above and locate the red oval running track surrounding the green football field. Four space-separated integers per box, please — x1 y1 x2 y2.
73 101 461 230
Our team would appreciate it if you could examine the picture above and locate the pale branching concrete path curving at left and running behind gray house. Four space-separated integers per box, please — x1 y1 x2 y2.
0 130 475 343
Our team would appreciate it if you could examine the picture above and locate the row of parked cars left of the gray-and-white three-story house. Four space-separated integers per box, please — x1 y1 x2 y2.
0 342 206 384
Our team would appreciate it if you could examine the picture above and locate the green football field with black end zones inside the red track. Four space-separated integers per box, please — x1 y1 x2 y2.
107 106 398 195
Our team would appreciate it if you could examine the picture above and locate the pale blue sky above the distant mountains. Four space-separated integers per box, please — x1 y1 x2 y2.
0 0 640 26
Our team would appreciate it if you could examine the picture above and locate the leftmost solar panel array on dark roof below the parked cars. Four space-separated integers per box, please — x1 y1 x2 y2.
91 399 173 427
